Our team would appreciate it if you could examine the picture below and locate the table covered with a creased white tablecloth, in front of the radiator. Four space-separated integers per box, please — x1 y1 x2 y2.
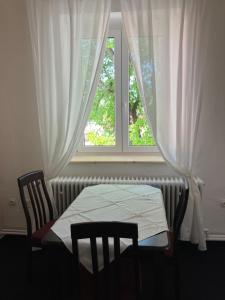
43 184 168 269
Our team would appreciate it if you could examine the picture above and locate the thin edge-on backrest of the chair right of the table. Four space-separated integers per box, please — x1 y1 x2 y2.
173 180 189 240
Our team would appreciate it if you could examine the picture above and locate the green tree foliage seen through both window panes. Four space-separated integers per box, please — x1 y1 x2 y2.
85 38 155 146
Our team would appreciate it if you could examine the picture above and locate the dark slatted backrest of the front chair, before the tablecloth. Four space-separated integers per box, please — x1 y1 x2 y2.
71 222 140 299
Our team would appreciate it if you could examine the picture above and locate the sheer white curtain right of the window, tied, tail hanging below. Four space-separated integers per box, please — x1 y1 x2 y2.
121 0 210 250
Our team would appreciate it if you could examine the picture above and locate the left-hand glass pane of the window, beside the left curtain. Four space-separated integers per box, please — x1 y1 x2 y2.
85 38 115 146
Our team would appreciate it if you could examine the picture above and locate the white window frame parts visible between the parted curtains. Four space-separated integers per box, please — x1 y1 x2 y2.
78 15 159 155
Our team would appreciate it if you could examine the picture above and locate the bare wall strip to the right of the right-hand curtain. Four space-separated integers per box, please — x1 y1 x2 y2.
196 1 225 237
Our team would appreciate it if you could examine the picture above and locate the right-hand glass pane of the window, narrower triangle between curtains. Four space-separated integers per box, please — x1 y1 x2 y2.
128 59 156 146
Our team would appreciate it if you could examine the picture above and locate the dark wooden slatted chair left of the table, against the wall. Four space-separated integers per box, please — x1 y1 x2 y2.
17 171 55 281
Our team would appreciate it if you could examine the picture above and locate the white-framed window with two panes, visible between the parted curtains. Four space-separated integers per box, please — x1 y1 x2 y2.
80 12 157 153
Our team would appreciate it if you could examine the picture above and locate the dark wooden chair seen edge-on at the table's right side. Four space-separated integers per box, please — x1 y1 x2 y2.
164 181 189 300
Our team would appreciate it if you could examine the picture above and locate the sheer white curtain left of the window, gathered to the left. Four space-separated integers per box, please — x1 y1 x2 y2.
27 0 111 179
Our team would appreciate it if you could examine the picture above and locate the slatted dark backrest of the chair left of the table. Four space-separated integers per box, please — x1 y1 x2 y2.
17 171 53 238
